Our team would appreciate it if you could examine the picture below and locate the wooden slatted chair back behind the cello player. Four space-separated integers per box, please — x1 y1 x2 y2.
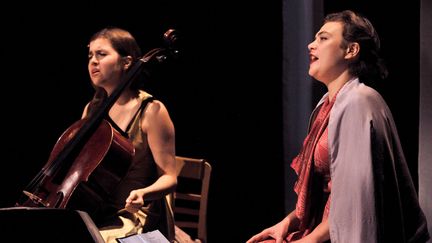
173 156 212 243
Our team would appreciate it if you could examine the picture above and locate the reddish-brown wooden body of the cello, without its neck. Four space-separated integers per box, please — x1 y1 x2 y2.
16 119 135 215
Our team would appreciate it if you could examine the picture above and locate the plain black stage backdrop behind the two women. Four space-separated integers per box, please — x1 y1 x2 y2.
0 0 419 243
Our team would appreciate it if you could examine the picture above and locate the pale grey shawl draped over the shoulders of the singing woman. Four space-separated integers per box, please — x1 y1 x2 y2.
312 78 429 243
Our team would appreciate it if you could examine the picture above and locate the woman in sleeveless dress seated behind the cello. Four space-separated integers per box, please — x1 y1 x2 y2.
82 27 177 243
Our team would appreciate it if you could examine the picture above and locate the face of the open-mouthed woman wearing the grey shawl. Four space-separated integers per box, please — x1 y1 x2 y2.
308 22 348 84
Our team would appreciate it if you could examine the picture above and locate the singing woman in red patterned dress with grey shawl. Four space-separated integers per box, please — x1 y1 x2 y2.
247 10 429 243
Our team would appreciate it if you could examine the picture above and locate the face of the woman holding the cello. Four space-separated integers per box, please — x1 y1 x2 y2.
88 38 125 93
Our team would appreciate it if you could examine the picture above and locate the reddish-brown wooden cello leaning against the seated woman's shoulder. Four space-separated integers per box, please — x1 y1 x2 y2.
15 29 178 215
